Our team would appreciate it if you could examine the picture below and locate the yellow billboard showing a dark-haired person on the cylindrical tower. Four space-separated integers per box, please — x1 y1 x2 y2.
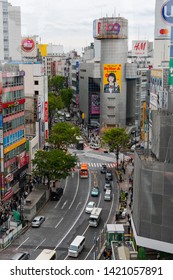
103 64 122 93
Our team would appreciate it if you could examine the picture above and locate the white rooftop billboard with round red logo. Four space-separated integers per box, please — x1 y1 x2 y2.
21 36 37 58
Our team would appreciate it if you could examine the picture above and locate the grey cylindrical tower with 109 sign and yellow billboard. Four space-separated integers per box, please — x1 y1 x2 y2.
93 17 128 127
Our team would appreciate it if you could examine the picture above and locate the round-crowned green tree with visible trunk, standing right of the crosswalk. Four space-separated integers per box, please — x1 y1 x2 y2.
102 128 129 169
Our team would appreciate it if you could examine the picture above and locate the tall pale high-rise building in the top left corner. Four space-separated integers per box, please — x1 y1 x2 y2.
0 0 21 61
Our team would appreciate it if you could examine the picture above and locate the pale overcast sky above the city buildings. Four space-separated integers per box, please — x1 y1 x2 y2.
8 0 155 54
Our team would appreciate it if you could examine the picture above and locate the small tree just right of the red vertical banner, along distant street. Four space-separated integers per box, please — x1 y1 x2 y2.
48 92 64 130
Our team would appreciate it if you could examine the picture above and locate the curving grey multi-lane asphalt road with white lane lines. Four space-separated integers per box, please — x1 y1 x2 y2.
0 151 118 260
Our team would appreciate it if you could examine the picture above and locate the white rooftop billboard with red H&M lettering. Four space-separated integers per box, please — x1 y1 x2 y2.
132 40 148 57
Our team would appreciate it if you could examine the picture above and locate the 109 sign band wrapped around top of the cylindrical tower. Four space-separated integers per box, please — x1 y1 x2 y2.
93 17 128 39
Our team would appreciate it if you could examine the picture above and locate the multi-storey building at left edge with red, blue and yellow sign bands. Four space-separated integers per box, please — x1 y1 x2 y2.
0 65 28 201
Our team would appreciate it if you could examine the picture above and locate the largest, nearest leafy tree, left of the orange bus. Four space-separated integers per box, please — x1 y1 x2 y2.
32 149 77 187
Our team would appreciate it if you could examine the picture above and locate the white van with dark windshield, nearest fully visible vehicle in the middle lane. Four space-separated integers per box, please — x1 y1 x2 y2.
68 235 85 258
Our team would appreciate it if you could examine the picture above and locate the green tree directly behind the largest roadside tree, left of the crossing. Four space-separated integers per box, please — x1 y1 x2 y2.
49 122 80 150
